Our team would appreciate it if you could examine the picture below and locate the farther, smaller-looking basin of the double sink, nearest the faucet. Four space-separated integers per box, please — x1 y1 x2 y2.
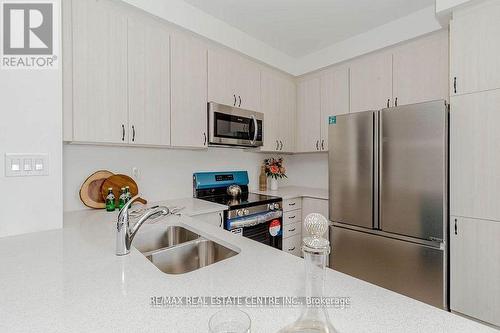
132 225 200 254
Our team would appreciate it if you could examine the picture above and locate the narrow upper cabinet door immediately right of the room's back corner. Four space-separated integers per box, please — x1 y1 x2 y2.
296 77 321 152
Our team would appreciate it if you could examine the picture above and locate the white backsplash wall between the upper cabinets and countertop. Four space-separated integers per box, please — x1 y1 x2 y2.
64 145 328 211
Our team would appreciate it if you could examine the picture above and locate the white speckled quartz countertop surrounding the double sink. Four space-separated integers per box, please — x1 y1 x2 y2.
0 201 496 333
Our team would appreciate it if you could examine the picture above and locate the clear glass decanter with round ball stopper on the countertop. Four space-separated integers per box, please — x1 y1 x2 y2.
279 213 338 333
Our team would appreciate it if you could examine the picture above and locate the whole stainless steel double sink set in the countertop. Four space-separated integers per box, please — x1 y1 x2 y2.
133 225 238 274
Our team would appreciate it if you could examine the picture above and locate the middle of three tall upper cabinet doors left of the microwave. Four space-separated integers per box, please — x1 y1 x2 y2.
128 18 170 146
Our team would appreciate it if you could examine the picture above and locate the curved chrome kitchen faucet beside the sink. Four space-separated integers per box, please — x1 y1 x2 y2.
116 195 170 256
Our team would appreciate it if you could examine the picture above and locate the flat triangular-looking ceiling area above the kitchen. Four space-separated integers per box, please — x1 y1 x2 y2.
184 0 435 58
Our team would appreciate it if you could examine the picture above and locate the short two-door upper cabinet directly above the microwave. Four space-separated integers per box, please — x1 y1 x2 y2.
208 49 260 111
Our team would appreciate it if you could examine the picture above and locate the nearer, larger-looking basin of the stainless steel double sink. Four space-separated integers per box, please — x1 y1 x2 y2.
143 238 238 274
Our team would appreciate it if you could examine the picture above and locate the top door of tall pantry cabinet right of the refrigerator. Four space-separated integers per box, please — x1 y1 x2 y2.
450 1 500 95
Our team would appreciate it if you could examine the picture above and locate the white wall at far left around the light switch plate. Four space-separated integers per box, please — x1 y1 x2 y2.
0 11 63 237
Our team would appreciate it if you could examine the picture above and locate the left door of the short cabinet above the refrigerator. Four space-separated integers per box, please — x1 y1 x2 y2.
350 52 392 112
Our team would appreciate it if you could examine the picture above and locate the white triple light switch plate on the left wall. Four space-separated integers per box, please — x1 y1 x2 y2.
5 154 49 177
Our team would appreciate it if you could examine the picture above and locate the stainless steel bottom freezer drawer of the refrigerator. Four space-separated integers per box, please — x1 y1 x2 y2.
330 226 447 308
